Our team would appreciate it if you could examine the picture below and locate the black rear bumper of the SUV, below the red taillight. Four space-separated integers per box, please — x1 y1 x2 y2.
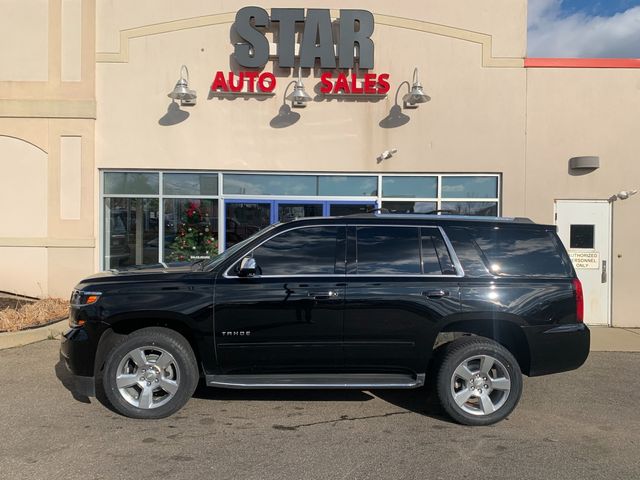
523 323 590 377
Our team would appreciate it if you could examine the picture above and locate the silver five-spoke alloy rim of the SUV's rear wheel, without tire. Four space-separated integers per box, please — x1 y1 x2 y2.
451 355 511 416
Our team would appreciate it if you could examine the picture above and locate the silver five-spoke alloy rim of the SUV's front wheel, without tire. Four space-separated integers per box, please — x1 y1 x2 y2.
116 346 180 410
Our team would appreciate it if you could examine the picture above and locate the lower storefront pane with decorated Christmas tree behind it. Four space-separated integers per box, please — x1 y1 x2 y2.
163 198 219 262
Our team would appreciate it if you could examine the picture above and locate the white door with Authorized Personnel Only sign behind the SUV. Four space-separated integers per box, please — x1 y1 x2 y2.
556 200 611 325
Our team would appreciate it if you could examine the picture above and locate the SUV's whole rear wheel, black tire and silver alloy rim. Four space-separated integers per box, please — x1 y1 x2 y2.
436 337 522 426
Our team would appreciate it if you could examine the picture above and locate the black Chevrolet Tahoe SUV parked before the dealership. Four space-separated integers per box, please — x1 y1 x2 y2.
61 214 589 425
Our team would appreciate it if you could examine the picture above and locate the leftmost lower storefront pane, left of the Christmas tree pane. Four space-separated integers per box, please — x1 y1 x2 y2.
104 198 159 269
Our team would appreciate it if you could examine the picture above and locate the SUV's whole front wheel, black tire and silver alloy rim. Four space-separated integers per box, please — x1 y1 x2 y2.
102 327 198 419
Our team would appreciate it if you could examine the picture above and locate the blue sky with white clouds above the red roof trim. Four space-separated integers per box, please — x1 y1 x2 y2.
527 0 640 58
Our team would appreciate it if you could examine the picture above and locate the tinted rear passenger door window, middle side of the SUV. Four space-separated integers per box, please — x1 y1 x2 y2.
356 227 421 275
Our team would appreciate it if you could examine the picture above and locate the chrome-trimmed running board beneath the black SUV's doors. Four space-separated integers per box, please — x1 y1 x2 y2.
206 373 425 390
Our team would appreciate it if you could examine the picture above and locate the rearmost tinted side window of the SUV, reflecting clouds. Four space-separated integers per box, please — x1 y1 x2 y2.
470 227 570 277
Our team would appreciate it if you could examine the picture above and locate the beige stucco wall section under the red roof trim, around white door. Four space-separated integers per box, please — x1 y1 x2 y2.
525 69 640 327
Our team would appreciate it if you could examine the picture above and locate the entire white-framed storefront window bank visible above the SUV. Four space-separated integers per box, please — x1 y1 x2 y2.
101 171 501 268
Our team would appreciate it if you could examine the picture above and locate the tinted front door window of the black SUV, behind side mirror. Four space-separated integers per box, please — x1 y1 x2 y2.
253 226 344 275
